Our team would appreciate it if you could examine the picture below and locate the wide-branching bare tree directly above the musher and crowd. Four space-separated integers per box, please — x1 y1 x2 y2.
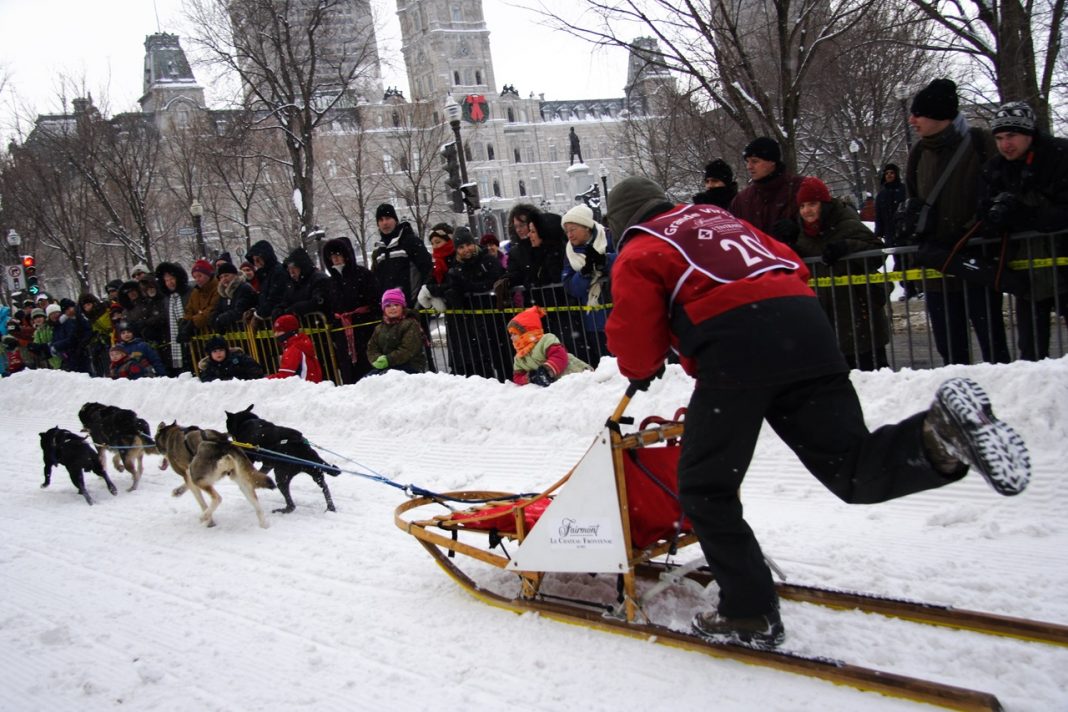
539 0 876 167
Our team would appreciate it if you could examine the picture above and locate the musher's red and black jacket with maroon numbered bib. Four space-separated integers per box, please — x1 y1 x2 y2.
606 205 846 385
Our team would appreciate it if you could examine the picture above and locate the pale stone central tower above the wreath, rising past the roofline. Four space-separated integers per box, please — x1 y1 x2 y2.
397 0 497 104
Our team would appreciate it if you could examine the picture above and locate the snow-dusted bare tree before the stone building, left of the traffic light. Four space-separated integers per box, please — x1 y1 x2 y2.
188 0 378 243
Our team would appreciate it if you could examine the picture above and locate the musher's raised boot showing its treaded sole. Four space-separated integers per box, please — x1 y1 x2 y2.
924 378 1031 496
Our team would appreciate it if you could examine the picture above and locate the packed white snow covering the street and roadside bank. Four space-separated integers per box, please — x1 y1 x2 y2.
0 359 1068 712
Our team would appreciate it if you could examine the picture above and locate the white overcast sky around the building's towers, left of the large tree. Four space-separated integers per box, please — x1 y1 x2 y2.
0 0 627 142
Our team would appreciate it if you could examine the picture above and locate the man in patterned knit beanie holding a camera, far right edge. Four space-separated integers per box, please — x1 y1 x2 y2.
983 101 1068 361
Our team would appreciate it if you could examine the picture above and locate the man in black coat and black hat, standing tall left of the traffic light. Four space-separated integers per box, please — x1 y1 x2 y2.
371 203 434 306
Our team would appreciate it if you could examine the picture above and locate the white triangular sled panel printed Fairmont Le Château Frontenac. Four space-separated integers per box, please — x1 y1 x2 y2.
508 429 627 573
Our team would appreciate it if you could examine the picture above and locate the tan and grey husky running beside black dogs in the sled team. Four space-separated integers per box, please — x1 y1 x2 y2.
186 430 274 528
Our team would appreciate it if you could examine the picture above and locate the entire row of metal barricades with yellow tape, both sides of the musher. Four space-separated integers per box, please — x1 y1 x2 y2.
179 232 1068 383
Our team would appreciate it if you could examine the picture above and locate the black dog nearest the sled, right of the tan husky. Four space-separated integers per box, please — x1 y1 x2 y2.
226 406 341 513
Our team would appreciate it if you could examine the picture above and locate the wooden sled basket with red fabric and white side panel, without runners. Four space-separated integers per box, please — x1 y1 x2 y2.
394 394 696 619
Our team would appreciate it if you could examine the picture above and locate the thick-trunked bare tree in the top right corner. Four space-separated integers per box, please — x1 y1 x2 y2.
910 0 1066 128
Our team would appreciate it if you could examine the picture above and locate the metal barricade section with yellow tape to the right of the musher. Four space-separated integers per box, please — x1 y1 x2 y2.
805 232 1068 369
